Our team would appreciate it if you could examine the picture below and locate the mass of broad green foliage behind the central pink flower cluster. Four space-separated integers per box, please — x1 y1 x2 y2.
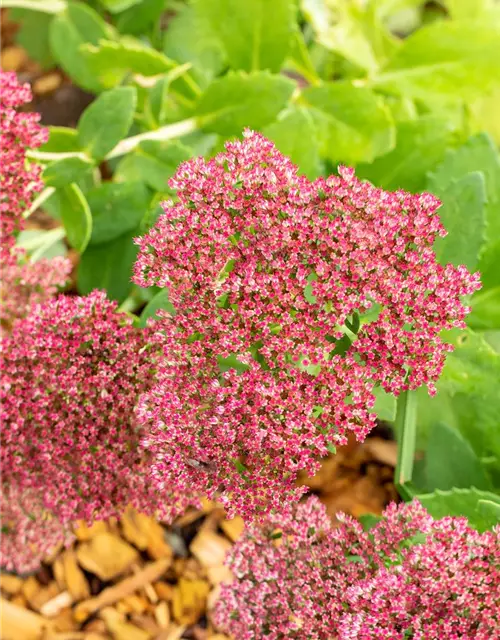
6 0 500 529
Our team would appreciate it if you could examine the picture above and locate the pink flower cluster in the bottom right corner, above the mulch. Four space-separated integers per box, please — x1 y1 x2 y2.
215 498 500 640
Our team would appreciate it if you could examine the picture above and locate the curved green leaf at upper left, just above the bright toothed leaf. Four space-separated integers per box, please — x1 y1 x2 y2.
49 2 114 92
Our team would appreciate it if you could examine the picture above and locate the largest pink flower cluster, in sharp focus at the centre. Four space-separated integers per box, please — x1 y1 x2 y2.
135 131 479 517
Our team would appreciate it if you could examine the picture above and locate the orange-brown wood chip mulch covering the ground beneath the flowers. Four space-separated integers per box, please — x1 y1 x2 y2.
0 428 397 640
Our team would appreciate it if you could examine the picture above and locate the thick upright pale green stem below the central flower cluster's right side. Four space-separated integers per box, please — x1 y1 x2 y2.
395 391 417 500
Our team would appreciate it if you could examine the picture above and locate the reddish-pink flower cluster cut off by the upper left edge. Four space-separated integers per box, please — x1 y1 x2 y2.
0 70 48 264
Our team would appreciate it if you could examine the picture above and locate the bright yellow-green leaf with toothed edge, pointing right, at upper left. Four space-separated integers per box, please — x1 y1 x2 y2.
80 36 181 88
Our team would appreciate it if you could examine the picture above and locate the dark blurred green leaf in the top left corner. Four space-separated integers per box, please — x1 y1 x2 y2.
9 9 54 69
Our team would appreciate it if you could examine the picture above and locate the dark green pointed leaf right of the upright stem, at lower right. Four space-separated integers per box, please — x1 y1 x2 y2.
425 423 491 491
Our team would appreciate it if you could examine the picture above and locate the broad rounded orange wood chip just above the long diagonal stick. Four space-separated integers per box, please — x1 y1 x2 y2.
76 533 138 581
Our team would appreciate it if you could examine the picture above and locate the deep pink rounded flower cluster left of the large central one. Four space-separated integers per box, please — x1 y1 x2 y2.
0 292 195 572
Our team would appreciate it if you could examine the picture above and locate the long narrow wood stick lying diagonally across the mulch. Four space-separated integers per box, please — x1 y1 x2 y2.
75 558 170 622
